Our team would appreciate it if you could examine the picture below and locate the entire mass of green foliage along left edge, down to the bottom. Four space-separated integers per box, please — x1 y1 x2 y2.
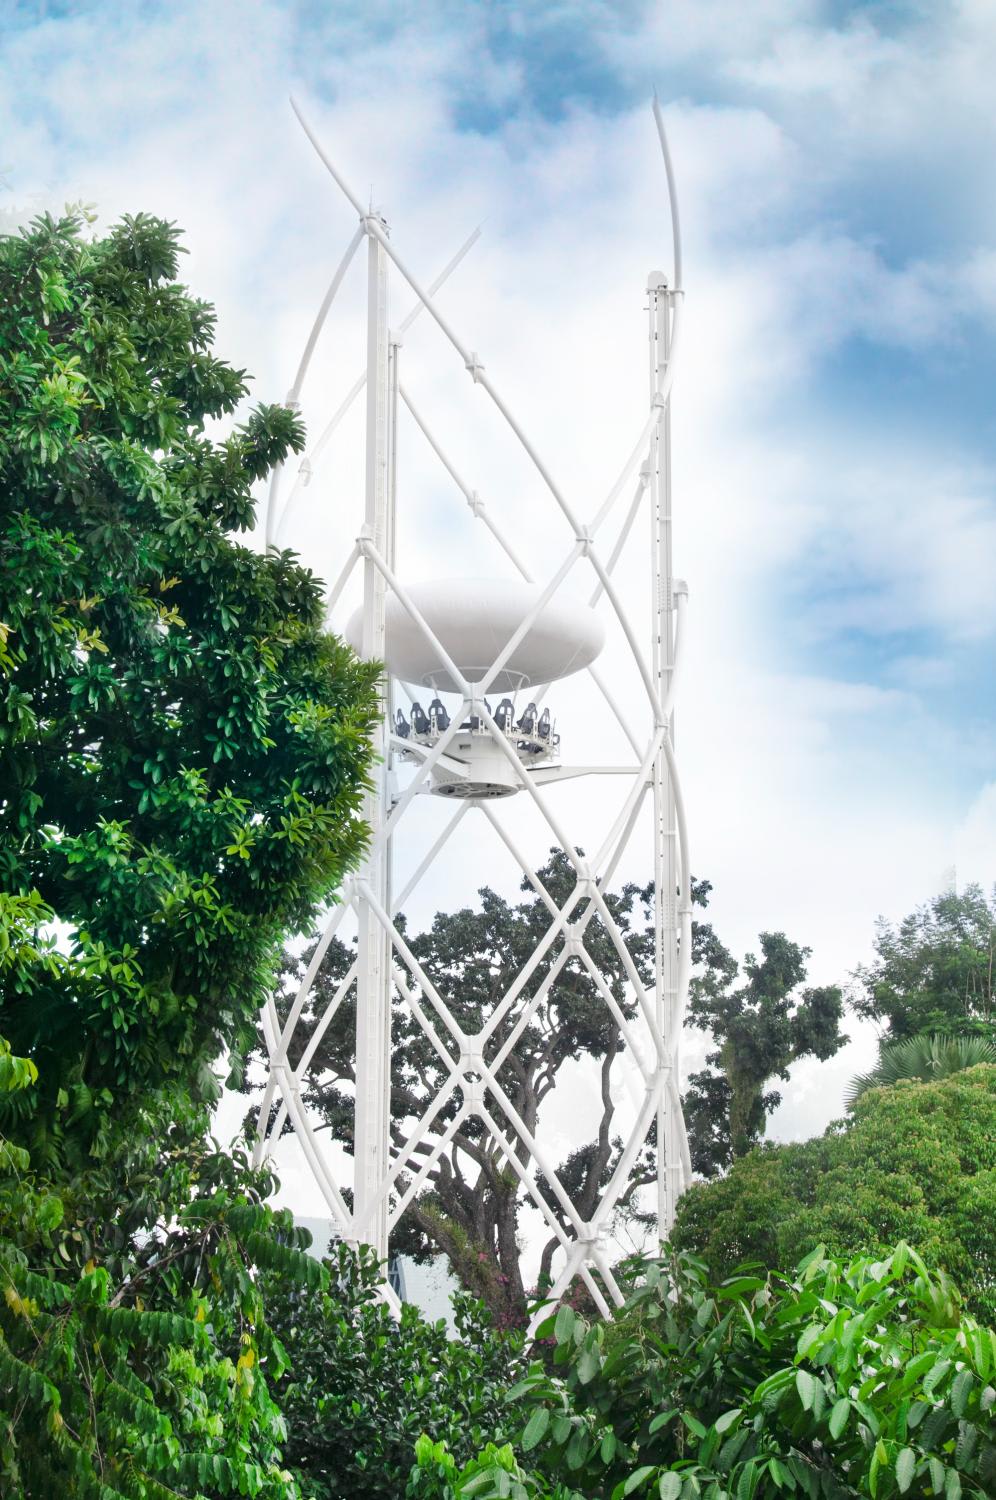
0 213 378 1500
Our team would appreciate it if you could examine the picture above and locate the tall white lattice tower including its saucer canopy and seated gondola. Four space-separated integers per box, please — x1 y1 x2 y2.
257 101 692 1311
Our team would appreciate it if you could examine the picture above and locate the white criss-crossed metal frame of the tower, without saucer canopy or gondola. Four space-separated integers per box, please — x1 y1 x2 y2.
257 101 692 1313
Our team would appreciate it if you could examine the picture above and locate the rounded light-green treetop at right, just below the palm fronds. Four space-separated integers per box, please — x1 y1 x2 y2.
672 1065 996 1325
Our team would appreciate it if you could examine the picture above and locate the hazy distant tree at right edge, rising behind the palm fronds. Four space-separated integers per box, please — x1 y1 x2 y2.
849 885 996 1041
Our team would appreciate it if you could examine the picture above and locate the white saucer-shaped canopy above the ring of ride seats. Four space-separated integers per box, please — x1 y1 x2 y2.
345 578 605 693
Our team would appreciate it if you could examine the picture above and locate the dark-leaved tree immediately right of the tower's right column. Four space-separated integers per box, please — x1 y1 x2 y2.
684 930 848 1178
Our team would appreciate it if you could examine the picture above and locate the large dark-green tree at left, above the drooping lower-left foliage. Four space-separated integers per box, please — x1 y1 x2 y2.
0 202 377 1161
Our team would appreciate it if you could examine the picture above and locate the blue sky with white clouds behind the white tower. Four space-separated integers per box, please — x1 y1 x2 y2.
0 0 996 1194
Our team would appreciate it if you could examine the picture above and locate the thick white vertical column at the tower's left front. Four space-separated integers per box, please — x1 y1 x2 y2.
353 222 393 1260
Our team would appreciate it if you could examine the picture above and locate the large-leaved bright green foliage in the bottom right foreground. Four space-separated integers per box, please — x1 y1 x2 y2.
423 1245 996 1500
